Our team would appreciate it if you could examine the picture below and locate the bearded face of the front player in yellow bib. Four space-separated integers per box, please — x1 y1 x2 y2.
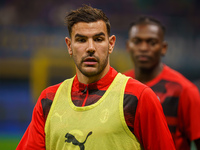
65 20 116 83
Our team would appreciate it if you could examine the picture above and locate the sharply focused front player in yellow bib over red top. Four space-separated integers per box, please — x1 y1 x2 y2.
17 5 175 150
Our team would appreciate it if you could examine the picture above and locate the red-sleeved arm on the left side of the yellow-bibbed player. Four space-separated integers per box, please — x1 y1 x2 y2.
16 92 45 150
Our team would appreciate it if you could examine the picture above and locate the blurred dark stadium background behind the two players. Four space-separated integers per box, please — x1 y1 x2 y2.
0 0 200 150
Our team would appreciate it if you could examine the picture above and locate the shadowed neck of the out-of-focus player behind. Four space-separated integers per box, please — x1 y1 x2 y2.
135 63 163 83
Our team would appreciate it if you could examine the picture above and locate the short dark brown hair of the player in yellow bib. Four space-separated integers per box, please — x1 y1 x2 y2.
65 5 110 36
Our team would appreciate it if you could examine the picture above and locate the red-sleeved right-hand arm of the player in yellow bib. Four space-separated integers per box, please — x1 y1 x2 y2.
134 88 175 150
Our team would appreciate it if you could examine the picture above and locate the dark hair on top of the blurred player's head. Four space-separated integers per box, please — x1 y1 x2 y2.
129 15 166 35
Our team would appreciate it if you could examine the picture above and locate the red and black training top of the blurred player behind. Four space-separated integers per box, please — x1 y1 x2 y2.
124 65 200 150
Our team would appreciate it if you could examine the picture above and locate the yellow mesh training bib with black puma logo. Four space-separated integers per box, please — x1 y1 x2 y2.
45 73 141 150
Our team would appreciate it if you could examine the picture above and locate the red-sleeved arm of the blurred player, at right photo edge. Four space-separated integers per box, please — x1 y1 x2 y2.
178 85 200 150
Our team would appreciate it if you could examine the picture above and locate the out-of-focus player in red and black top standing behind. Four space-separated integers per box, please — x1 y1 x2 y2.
124 16 200 150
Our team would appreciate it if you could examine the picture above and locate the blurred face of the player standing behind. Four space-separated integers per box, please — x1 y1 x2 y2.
127 24 167 70
